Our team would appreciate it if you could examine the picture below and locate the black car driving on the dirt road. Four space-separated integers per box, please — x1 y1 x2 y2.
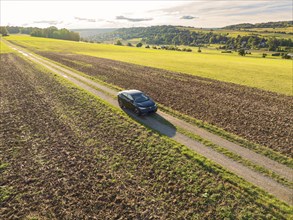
118 90 158 115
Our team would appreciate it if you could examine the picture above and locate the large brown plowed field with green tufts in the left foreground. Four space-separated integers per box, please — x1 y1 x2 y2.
0 54 288 219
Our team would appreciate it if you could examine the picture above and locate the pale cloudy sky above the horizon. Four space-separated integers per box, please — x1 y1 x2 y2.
0 0 293 29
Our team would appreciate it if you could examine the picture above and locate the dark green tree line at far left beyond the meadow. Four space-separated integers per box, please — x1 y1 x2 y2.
0 26 80 41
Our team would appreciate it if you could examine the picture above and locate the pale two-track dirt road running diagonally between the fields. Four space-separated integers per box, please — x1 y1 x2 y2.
5 42 293 205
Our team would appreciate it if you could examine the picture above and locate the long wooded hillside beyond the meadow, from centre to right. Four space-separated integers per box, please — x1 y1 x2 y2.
95 26 293 51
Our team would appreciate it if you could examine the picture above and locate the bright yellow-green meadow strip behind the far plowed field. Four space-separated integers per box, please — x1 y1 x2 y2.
5 35 293 95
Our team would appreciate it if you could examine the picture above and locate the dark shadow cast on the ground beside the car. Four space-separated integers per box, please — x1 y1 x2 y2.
123 109 177 137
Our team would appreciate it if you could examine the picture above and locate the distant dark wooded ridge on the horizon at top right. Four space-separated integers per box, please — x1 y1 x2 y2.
222 21 293 30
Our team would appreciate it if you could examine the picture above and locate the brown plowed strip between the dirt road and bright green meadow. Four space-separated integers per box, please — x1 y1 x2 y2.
40 52 293 157
